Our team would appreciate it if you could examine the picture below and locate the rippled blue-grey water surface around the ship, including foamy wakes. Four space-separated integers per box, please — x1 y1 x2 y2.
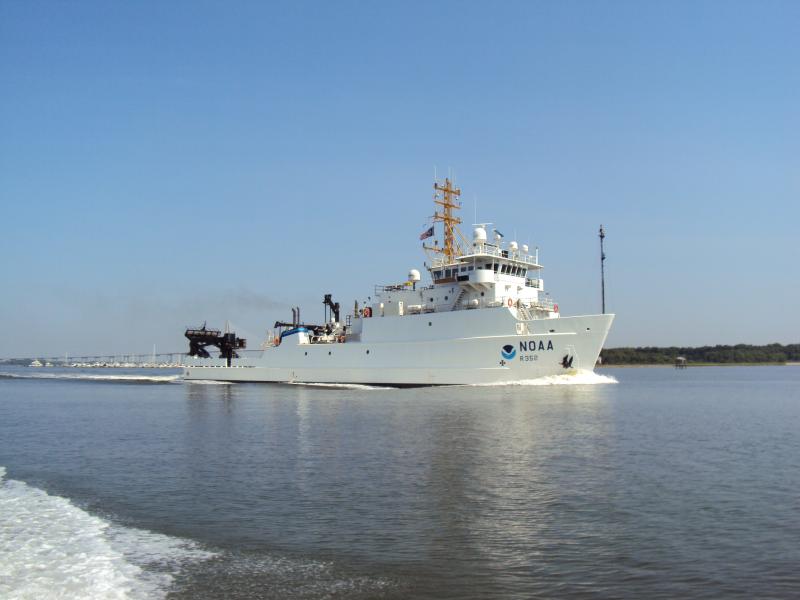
0 367 800 600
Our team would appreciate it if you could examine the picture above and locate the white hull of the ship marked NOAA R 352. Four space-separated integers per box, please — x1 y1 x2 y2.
184 307 614 386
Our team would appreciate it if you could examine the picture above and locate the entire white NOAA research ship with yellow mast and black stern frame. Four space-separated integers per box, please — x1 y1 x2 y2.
183 178 614 387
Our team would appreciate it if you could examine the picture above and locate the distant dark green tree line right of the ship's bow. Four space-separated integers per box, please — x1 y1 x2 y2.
601 344 800 365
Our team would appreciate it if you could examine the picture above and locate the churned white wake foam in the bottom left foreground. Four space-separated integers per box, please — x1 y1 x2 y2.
0 467 214 600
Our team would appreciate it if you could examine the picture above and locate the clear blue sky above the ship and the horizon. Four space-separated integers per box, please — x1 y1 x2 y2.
0 0 800 357
